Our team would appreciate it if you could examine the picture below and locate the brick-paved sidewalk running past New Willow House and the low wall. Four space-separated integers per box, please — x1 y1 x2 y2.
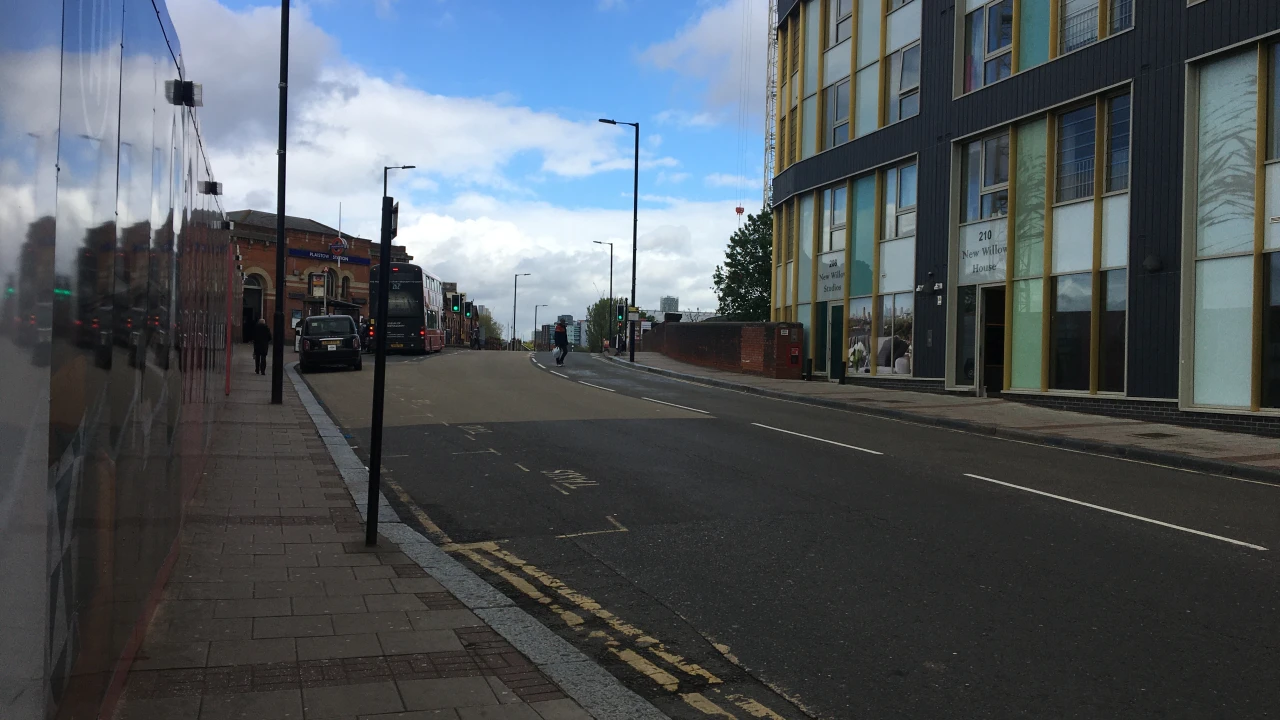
607 352 1280 483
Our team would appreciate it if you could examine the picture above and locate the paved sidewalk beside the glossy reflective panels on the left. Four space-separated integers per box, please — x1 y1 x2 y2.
116 352 591 720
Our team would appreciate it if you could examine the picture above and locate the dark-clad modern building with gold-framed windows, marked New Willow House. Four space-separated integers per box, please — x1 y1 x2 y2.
772 0 1280 432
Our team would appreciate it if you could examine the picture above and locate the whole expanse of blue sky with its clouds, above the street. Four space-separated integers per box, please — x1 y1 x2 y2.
168 0 765 324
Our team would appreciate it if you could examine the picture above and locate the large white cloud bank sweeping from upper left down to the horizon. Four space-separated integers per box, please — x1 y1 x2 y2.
169 0 736 332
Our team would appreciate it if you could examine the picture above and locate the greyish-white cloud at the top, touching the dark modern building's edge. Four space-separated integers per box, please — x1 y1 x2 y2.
640 0 769 122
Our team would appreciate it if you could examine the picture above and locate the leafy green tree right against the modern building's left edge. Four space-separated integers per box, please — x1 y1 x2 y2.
712 208 773 322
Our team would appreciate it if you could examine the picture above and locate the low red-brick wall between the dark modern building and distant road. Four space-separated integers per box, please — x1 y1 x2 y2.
637 317 804 379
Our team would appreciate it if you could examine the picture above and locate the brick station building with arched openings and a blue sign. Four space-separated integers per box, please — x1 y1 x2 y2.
227 210 413 342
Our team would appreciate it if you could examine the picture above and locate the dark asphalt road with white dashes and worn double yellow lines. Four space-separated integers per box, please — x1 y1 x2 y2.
307 352 1280 719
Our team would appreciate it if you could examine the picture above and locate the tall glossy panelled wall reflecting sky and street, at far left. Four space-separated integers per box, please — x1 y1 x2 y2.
0 0 236 720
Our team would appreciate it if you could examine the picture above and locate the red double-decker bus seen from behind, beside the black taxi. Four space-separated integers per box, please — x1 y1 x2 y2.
369 263 444 355
